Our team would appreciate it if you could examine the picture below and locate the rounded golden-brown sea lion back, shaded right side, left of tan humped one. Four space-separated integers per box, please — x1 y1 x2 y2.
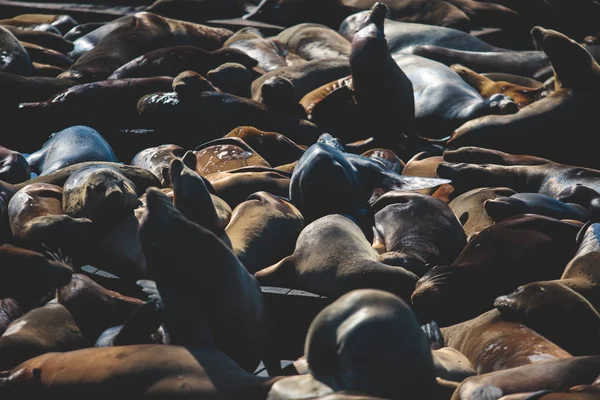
225 192 304 274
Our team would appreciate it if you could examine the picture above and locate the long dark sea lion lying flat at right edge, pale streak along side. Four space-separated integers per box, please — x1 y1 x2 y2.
437 146 600 199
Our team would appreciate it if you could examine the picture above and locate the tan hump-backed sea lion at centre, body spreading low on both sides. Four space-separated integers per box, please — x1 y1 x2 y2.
255 214 418 299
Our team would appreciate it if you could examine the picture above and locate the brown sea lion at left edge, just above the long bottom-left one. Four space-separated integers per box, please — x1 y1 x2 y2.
0 304 84 369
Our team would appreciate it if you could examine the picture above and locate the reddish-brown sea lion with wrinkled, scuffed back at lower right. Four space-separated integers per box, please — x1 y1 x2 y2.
441 310 572 375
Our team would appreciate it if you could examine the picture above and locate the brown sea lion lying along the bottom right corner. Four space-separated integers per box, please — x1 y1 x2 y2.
452 356 600 400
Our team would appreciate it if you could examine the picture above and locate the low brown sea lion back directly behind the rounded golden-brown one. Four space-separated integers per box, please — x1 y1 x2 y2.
206 167 292 209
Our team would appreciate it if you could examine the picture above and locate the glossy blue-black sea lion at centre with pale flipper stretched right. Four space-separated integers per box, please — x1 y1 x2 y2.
289 138 448 221
